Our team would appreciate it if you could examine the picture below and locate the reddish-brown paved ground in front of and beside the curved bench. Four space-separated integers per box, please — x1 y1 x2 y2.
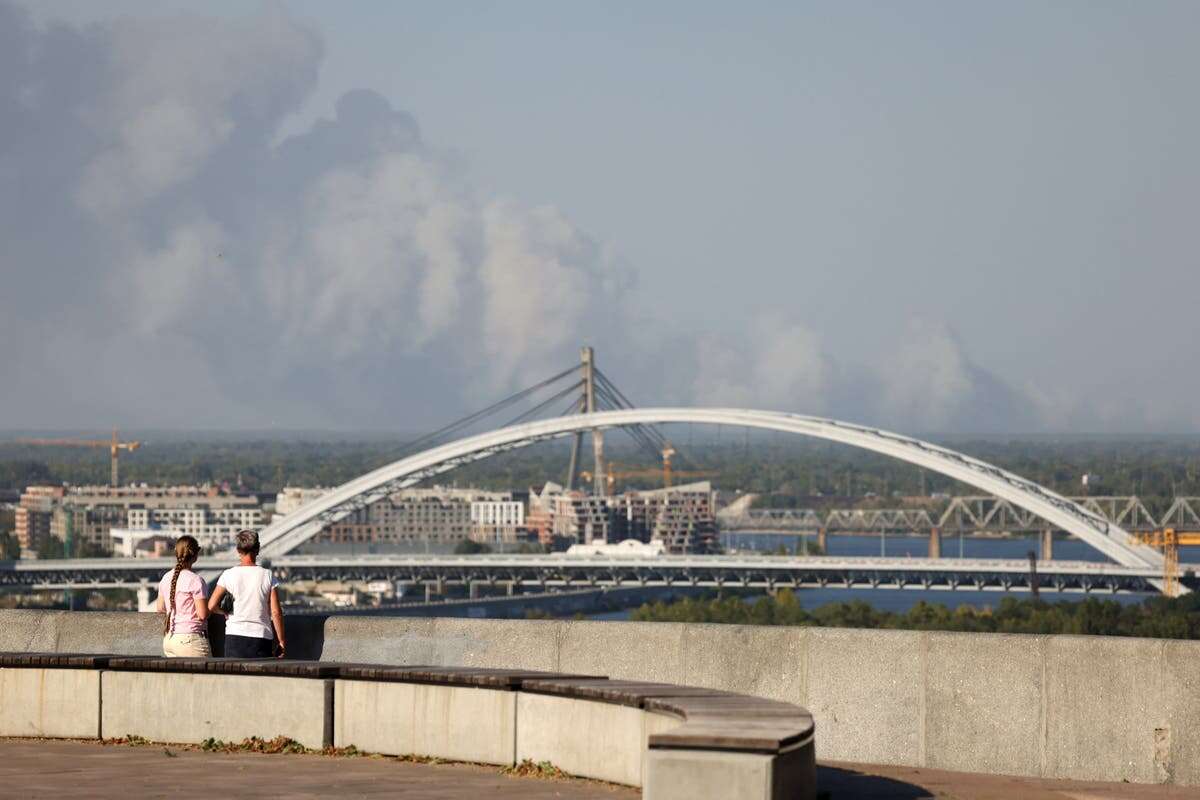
0 739 1200 800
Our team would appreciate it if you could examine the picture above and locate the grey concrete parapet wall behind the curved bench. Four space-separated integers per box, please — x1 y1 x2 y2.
0 612 1200 784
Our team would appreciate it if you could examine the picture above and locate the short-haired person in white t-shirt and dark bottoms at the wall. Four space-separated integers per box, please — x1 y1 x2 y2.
209 530 287 658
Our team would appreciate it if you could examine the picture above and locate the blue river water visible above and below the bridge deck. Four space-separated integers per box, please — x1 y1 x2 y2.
580 533 1200 620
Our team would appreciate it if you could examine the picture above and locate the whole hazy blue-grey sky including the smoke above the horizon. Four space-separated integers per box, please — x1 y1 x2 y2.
0 0 1200 433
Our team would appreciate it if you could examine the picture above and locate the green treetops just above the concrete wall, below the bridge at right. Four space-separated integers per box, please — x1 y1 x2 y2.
631 589 1200 639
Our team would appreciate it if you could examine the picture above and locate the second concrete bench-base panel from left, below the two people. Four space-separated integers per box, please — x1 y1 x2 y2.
99 672 326 747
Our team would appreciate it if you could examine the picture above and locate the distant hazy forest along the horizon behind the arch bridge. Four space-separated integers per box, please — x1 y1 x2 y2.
7 432 1200 511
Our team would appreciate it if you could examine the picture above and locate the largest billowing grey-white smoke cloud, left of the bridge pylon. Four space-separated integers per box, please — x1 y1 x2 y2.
0 2 623 427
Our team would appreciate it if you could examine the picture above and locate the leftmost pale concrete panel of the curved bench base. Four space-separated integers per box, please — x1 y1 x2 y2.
0 668 101 739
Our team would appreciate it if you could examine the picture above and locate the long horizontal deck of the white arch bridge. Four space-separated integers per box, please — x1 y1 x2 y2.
0 554 1162 594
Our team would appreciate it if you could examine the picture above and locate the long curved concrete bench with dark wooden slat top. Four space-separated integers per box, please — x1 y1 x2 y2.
0 652 816 800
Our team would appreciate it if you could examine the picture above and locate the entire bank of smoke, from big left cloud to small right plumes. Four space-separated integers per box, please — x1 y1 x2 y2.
0 0 1038 429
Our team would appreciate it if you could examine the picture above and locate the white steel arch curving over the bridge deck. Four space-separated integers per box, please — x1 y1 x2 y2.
253 408 1163 567
